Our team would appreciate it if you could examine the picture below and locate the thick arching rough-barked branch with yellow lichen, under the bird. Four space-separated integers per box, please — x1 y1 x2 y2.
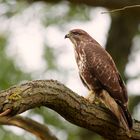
0 80 140 140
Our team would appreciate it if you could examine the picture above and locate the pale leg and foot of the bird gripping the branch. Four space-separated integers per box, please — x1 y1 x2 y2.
86 90 100 105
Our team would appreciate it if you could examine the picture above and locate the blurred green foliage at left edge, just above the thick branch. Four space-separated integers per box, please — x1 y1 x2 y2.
0 36 31 89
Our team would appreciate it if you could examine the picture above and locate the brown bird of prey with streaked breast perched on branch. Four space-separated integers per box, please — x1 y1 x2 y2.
65 29 132 132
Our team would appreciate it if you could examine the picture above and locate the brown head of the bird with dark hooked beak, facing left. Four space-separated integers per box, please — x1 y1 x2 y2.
65 29 91 47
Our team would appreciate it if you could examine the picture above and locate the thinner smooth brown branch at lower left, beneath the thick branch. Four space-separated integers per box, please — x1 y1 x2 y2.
0 116 57 140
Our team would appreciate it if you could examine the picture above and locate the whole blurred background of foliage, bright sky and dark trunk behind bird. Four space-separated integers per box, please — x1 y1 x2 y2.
0 0 140 140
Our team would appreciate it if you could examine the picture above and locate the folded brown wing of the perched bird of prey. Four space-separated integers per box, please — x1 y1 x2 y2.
84 42 128 103
